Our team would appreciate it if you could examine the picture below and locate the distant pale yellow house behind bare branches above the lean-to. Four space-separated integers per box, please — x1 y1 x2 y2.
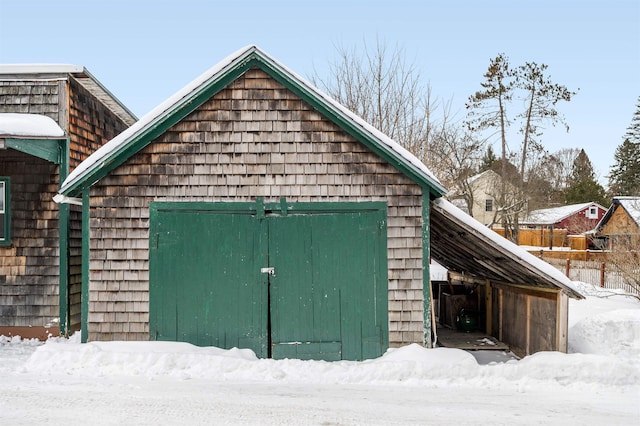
448 170 515 226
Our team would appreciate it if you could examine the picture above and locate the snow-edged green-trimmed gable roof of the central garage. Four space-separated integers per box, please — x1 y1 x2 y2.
60 46 446 196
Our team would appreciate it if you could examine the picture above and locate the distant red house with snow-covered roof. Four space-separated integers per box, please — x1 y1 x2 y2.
520 202 607 235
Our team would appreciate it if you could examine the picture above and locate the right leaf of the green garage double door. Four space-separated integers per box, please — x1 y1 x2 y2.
268 211 388 361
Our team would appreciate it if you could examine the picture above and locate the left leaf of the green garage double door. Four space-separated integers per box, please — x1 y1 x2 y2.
149 207 268 357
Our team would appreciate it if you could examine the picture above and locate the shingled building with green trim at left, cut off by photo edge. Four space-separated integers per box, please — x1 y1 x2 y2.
0 65 136 338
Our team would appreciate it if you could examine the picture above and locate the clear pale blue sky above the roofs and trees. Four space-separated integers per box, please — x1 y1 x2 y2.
0 0 640 183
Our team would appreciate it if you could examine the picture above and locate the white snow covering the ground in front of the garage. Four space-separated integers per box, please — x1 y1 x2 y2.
0 283 640 426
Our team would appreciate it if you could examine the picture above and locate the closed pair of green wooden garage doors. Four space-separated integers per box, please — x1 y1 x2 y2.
149 201 388 360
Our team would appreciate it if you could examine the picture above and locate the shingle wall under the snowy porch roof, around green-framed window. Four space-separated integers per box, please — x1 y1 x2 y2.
0 150 59 327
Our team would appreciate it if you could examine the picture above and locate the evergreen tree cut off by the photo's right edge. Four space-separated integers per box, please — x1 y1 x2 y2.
609 97 640 196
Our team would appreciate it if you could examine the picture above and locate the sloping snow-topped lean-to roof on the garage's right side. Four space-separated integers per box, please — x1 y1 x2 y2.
431 198 584 299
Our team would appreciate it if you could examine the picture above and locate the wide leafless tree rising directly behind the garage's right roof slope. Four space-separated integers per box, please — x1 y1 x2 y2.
312 40 484 195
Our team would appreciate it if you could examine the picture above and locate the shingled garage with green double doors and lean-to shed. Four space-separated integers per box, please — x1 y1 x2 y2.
56 46 582 360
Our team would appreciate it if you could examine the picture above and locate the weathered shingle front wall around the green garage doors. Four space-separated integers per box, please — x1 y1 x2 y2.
88 69 423 346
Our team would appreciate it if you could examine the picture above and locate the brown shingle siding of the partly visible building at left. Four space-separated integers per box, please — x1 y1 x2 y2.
0 72 135 337
